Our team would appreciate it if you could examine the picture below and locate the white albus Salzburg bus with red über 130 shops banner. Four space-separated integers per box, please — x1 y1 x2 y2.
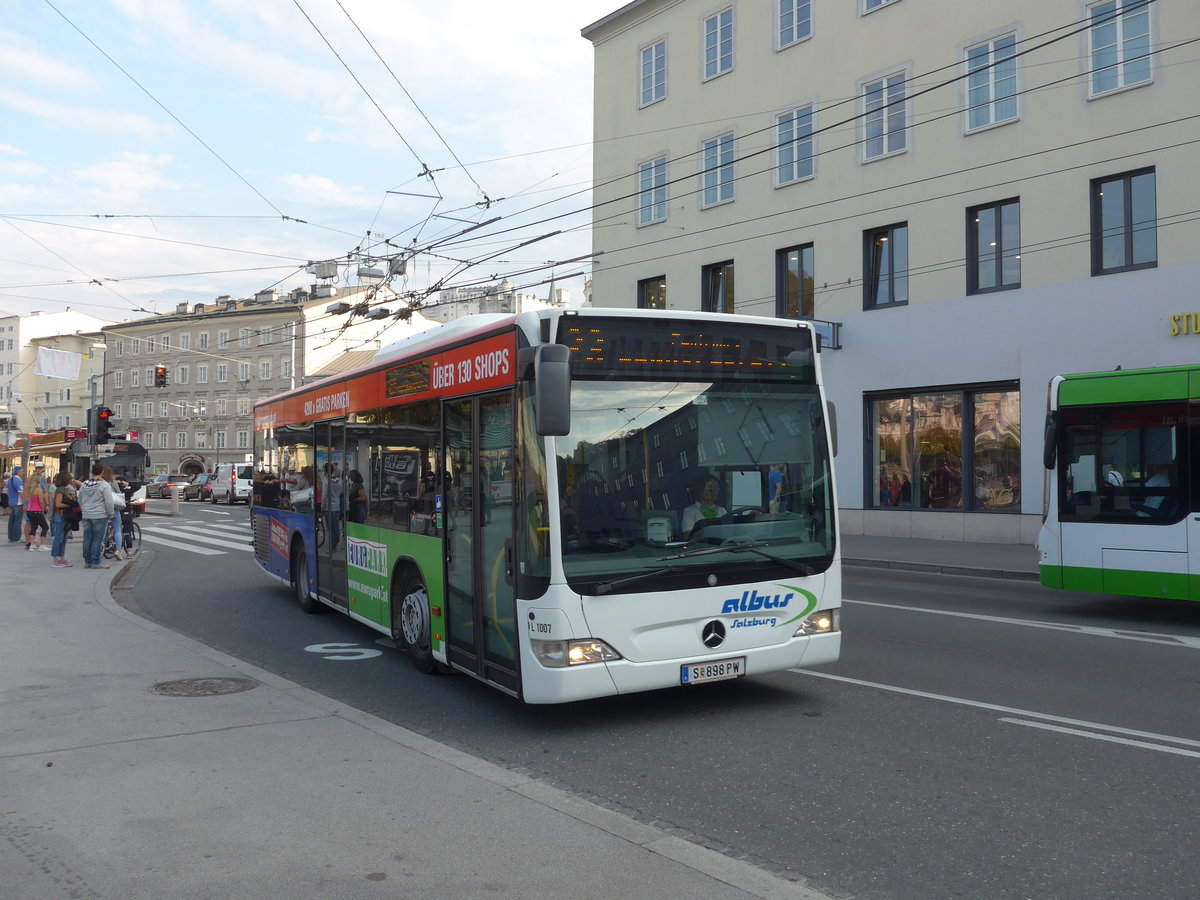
252 308 841 703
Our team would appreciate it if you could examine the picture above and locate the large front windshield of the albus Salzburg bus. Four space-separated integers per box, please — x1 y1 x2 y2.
557 379 834 593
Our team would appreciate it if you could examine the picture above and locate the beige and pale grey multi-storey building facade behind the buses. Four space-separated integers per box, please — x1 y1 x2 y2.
583 0 1200 544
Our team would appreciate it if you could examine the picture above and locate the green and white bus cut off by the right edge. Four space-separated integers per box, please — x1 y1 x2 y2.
1038 366 1200 600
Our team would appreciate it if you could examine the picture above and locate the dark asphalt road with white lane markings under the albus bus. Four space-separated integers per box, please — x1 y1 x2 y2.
125 504 1200 900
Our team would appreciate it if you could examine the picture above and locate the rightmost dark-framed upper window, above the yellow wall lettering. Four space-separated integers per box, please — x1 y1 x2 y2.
1092 169 1158 275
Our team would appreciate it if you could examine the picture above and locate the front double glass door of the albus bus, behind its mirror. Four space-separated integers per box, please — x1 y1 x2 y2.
443 392 518 692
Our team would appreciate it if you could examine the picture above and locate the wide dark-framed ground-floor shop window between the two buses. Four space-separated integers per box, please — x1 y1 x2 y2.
866 385 1021 512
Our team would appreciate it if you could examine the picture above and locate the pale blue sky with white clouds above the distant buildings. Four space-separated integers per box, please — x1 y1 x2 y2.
0 0 623 322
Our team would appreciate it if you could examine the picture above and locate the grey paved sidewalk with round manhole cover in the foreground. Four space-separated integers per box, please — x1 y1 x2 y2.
0 540 827 900
